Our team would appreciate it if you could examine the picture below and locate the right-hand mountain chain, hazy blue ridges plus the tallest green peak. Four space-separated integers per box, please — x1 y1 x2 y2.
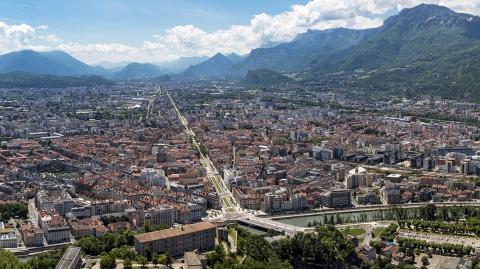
193 4 480 101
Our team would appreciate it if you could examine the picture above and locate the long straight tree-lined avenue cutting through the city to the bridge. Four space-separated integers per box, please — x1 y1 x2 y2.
164 89 242 213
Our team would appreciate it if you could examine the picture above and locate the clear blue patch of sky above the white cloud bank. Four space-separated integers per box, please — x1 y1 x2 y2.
0 0 308 46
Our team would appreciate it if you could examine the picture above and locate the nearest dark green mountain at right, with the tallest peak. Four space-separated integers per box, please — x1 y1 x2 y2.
311 4 480 101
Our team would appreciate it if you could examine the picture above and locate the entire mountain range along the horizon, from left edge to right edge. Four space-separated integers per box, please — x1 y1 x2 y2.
0 4 480 100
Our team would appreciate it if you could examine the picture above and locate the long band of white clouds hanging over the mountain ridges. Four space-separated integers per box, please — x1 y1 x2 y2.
0 0 480 63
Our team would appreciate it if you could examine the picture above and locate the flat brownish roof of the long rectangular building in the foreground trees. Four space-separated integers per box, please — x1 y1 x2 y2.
135 222 217 243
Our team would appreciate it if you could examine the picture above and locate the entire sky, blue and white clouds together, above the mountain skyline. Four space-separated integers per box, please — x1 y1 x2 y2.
0 0 480 63
